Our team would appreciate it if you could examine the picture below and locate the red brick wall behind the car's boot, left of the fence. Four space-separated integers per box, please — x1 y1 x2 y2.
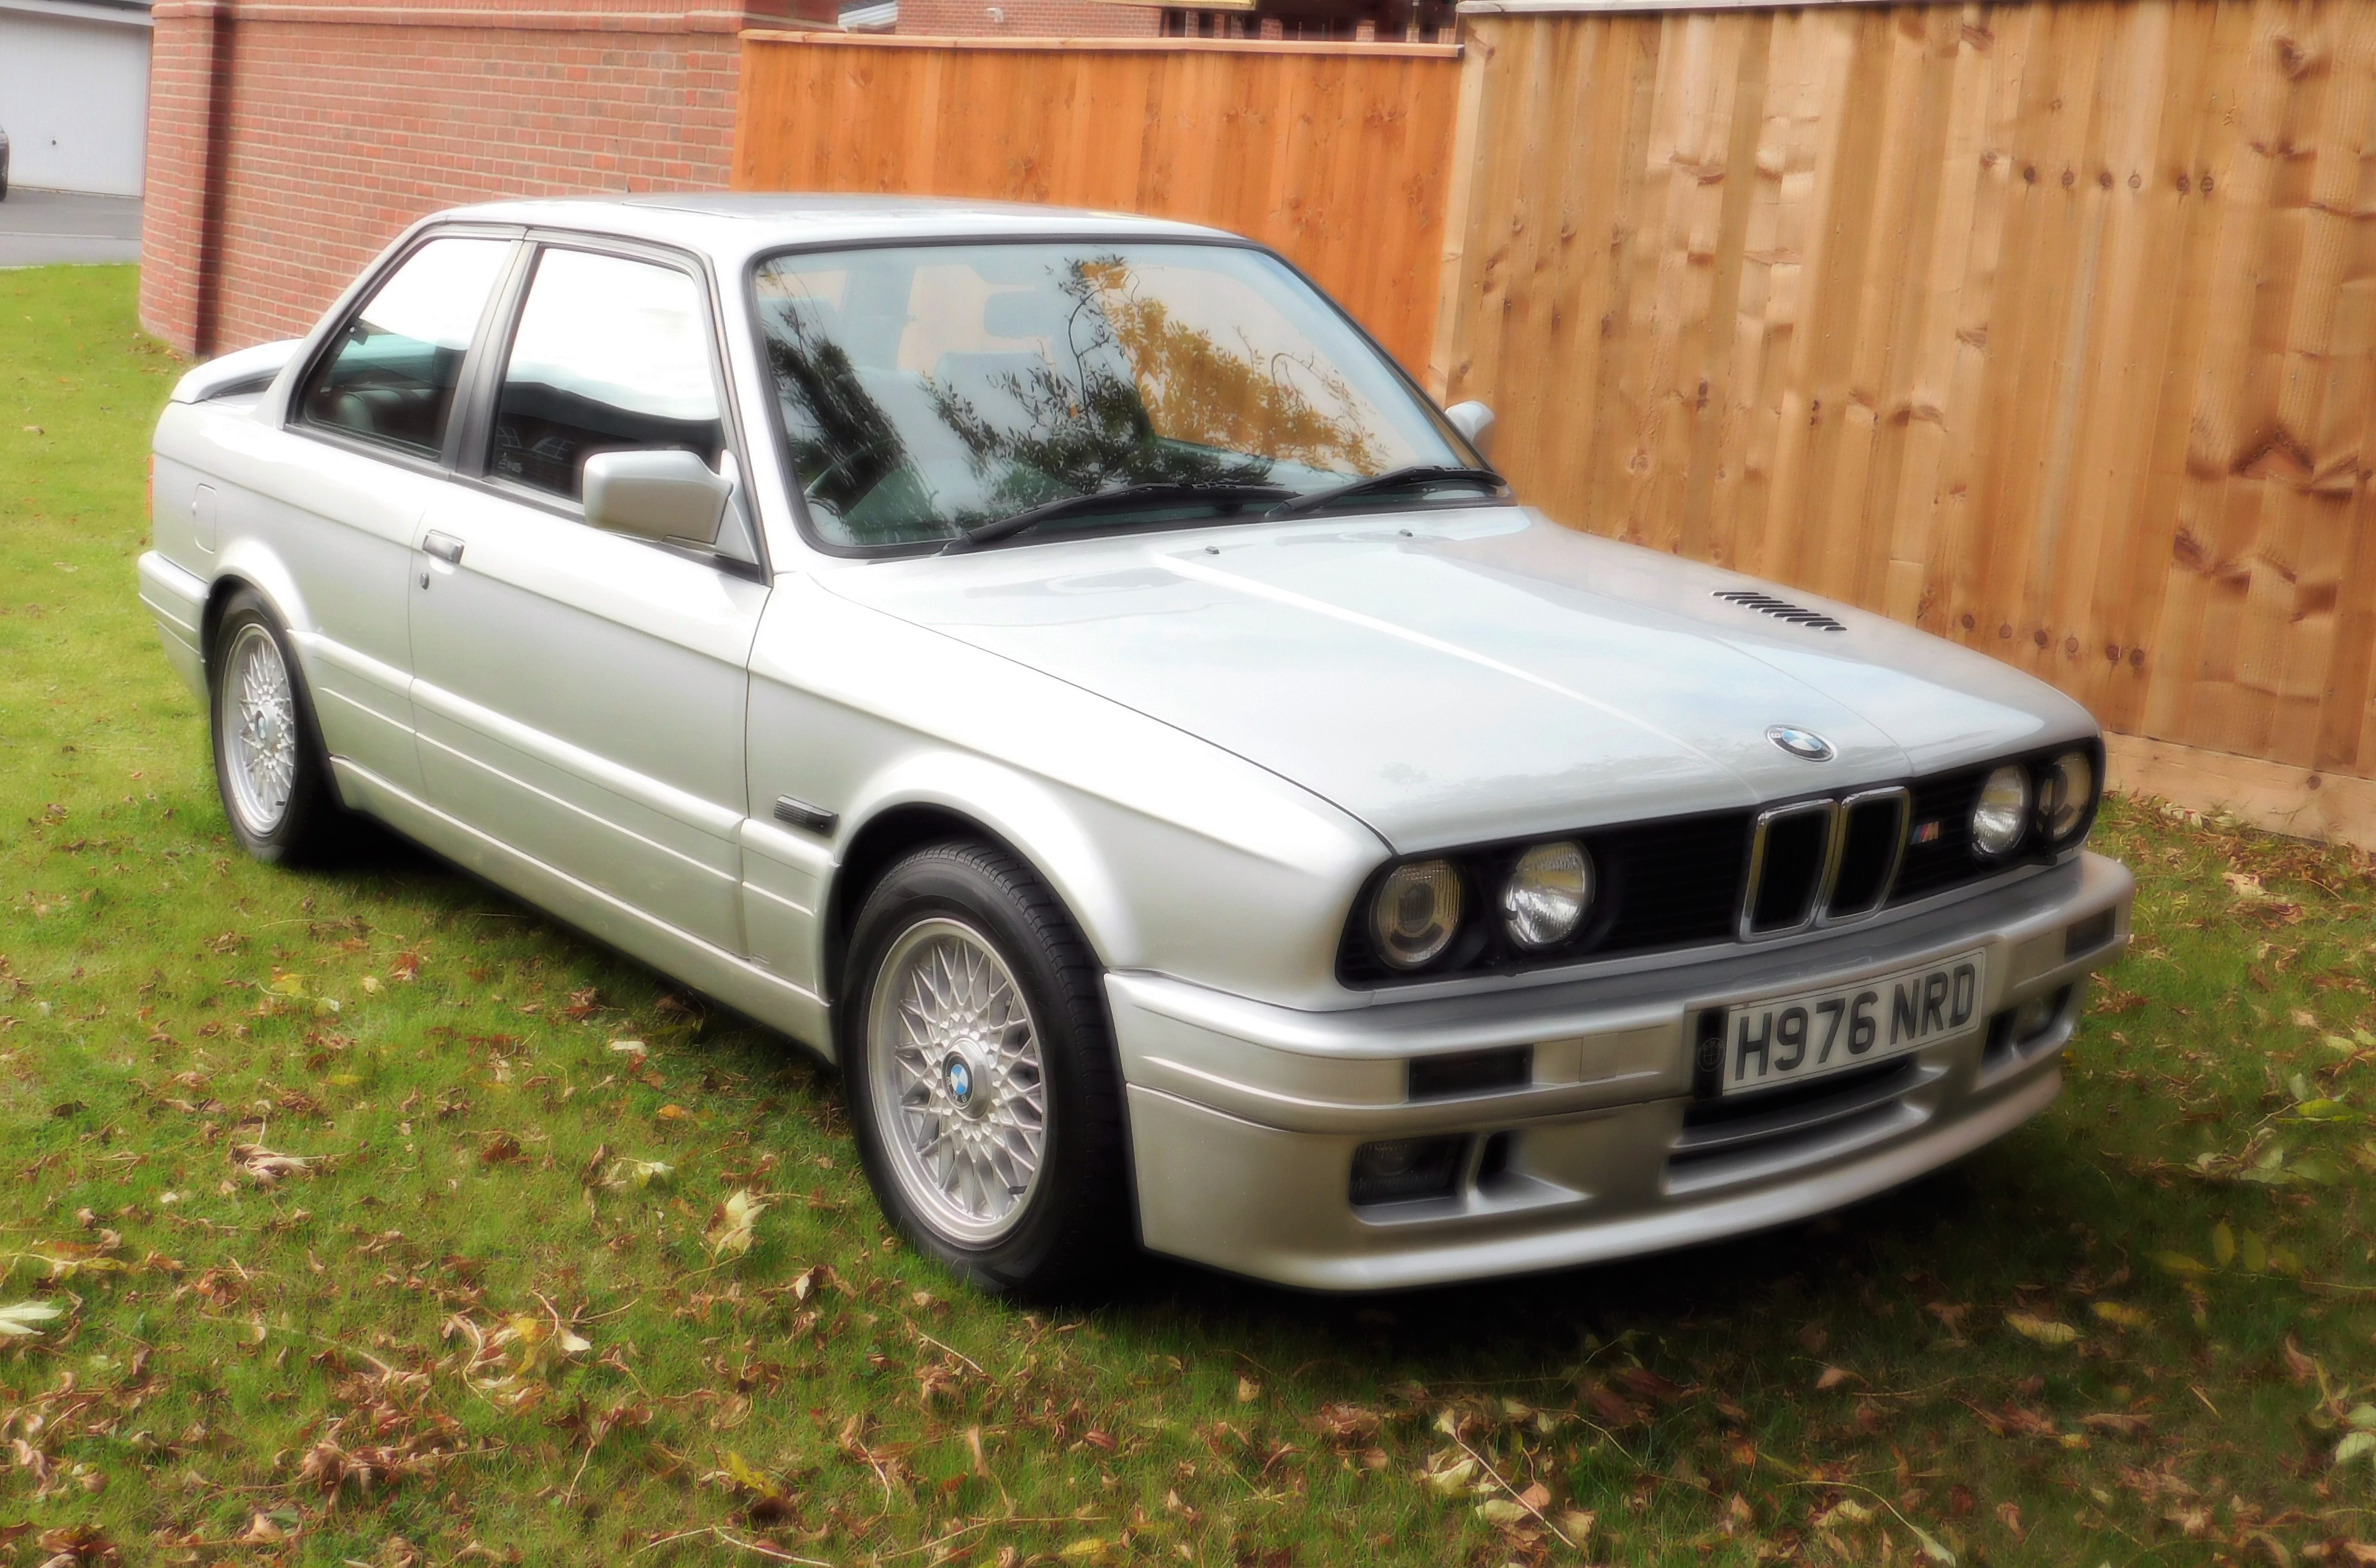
140 0 834 354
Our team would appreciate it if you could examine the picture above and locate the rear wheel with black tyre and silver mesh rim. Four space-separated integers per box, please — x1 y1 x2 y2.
207 589 347 865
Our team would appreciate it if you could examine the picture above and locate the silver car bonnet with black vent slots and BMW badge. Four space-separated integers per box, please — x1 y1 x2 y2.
827 508 2093 853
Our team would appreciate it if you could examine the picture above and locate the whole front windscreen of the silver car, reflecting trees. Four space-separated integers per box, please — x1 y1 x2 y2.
756 243 1478 549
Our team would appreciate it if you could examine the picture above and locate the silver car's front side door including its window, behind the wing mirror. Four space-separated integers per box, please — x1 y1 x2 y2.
411 240 767 955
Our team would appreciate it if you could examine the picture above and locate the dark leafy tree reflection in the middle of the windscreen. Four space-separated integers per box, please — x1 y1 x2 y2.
929 256 1271 523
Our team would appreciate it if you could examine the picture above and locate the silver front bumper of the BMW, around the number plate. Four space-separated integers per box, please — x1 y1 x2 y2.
1107 855 2136 1290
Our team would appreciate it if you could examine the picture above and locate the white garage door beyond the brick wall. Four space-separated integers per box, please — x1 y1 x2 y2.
0 10 149 195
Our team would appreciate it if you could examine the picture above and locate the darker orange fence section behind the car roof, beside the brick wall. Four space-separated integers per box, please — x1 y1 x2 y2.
734 33 1459 370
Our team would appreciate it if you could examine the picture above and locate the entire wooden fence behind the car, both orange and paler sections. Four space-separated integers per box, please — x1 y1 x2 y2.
734 0 2376 843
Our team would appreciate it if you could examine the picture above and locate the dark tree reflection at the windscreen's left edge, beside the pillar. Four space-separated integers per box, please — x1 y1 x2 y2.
765 302 929 544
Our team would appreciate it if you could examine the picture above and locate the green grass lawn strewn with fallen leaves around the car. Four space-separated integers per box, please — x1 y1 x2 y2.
0 268 2376 1568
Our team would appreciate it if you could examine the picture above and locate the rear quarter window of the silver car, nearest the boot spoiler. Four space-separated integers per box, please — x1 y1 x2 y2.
297 238 511 456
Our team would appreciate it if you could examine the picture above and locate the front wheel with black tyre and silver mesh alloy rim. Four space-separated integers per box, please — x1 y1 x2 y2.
836 843 1136 1297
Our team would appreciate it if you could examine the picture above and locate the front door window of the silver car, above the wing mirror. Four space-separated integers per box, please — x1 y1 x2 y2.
487 250 725 501
